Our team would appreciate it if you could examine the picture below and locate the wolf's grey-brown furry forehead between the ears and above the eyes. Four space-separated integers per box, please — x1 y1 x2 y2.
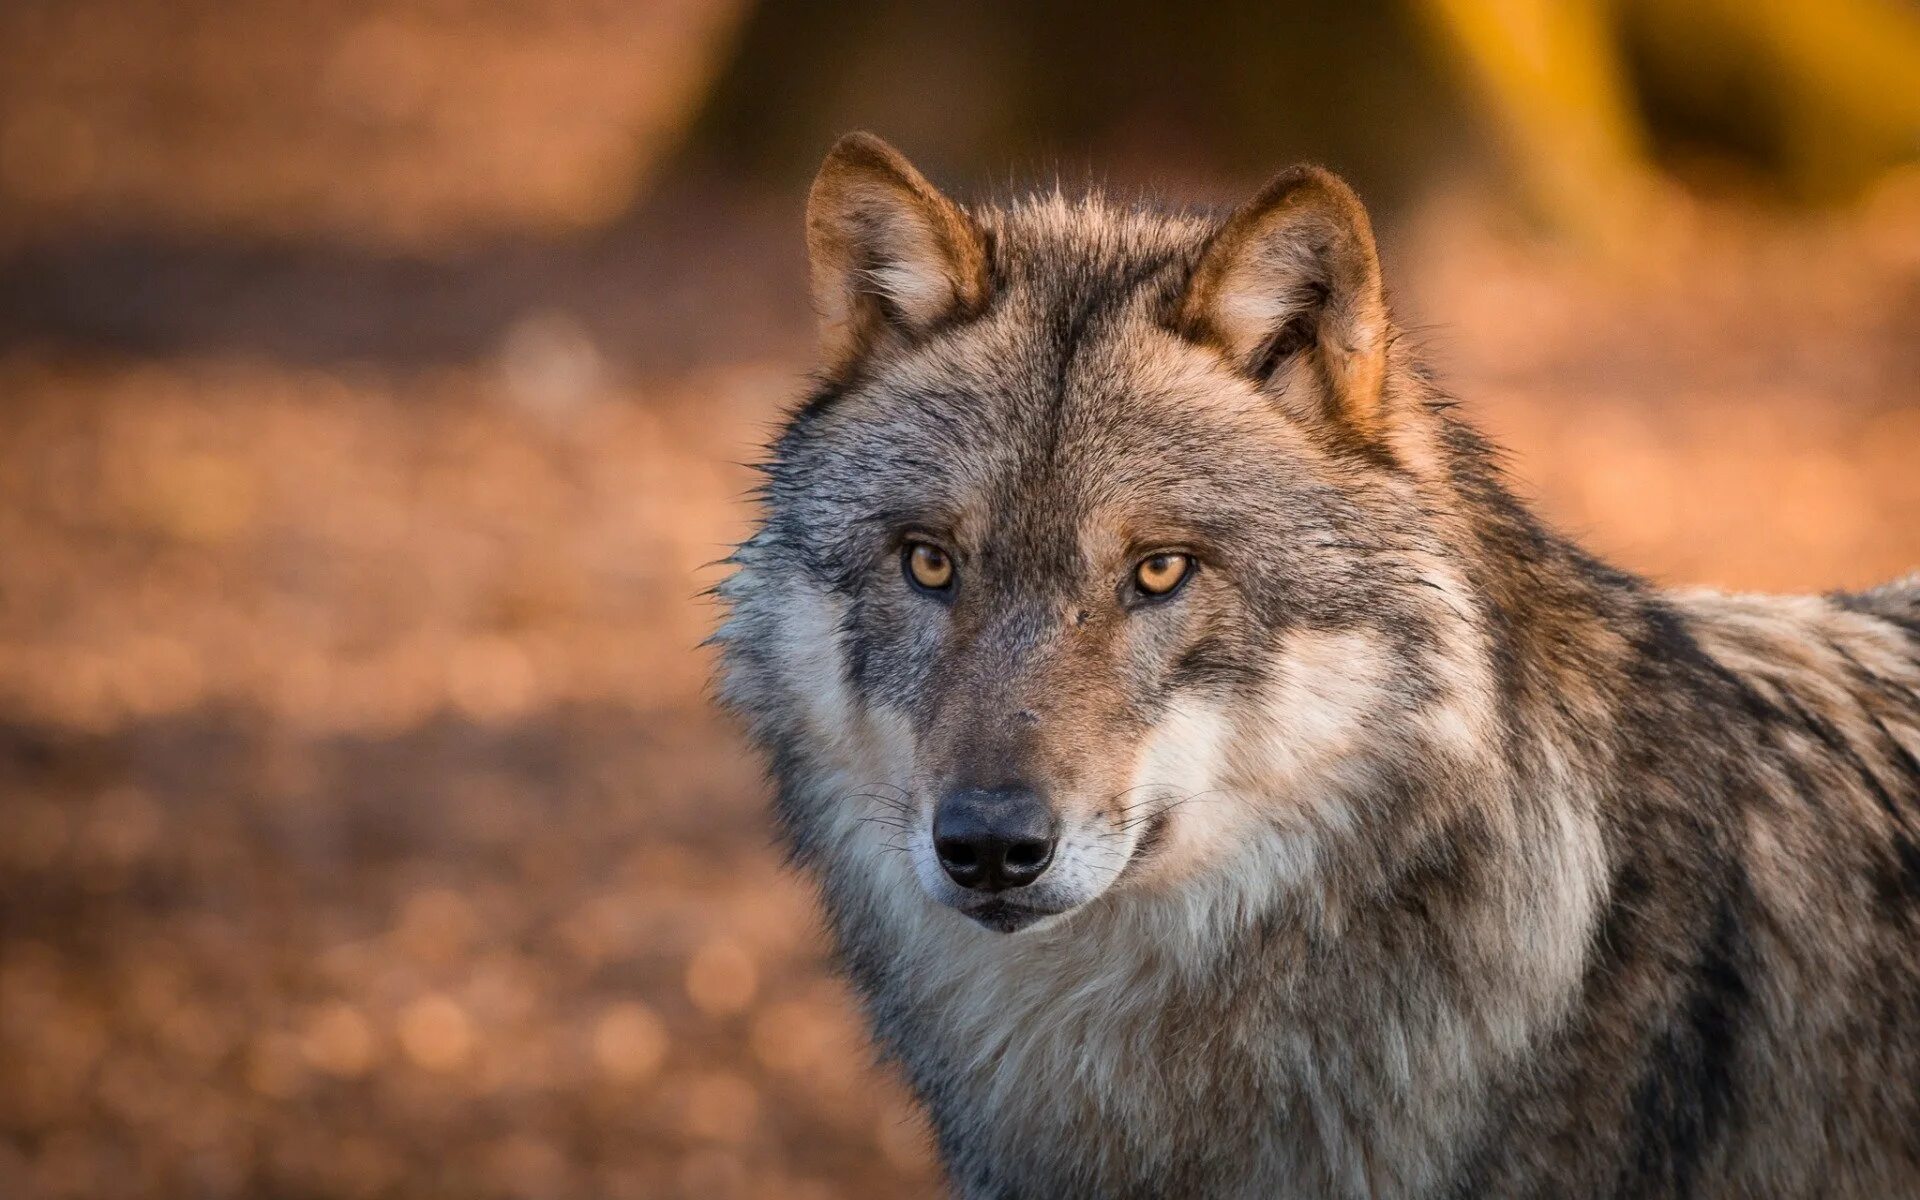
794 198 1273 547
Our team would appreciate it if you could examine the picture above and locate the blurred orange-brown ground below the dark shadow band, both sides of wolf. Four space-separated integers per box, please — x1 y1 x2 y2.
0 189 1920 1198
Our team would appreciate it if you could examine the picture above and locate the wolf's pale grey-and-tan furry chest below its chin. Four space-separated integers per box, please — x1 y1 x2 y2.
843 879 1478 1196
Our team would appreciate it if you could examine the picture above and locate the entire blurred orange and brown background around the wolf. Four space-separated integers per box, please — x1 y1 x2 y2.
0 0 1920 1200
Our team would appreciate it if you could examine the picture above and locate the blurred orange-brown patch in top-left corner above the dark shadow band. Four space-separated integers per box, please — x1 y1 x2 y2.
0 0 741 248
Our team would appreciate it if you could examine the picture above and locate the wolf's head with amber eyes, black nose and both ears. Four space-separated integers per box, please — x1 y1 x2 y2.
722 134 1486 931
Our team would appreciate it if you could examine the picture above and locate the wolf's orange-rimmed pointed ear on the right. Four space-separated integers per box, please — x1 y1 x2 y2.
1179 167 1388 436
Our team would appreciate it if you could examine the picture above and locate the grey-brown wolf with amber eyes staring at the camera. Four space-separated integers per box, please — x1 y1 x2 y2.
716 134 1920 1200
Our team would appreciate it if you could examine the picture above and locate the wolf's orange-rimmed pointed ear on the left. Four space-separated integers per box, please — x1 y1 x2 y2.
806 132 987 372
